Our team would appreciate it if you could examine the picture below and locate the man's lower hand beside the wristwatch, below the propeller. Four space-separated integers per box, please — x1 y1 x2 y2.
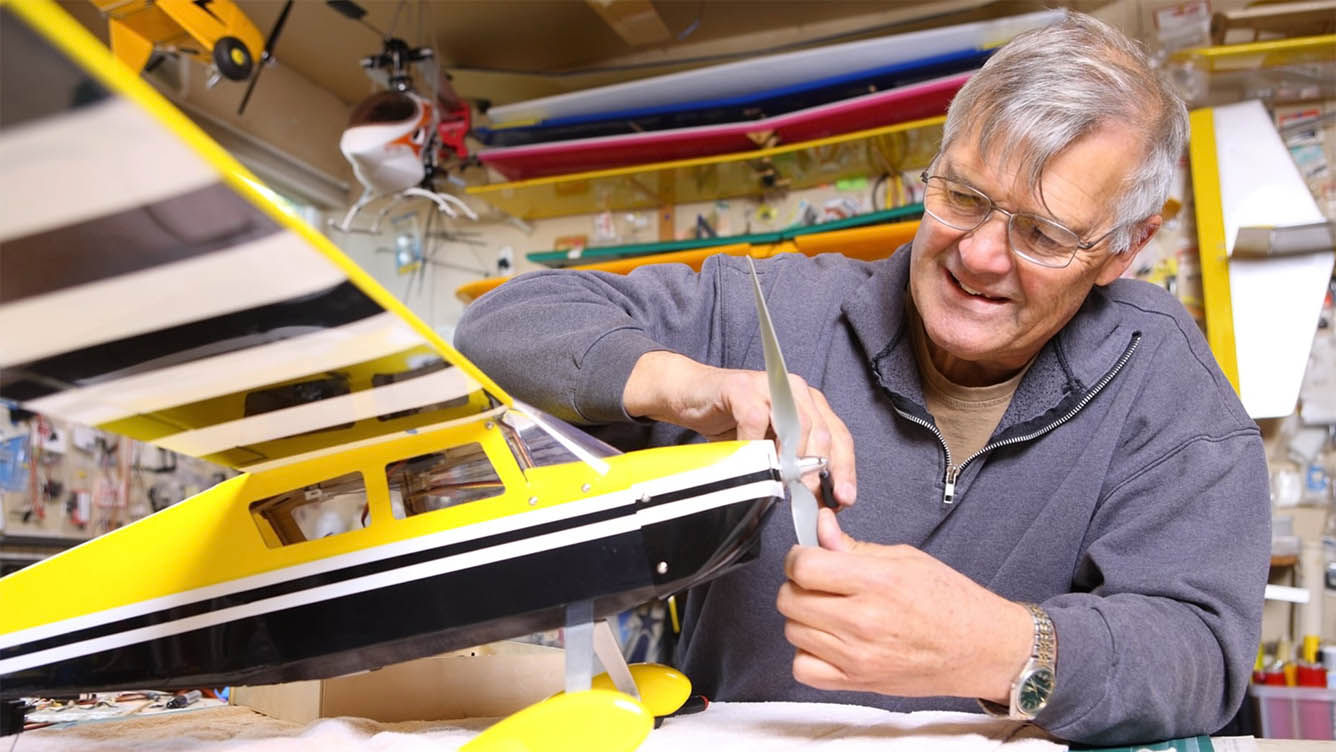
776 509 1034 704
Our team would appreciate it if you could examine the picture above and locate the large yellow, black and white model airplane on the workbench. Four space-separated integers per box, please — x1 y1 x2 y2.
0 0 806 749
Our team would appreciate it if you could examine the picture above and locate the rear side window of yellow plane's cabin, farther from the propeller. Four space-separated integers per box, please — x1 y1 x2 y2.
250 473 370 548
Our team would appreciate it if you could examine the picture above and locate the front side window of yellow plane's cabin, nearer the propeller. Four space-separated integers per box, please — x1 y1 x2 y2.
385 443 505 520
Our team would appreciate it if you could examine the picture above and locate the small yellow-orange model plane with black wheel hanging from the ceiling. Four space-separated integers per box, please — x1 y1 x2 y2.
90 0 293 115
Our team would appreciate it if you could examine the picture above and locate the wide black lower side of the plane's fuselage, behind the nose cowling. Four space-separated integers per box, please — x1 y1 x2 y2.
0 530 653 697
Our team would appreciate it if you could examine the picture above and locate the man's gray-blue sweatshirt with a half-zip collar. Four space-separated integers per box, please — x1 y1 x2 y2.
456 250 1271 744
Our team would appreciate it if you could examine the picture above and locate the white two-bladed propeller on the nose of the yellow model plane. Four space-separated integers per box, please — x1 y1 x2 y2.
747 256 818 546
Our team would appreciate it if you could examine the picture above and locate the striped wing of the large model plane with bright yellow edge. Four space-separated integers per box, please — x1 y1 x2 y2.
0 0 512 472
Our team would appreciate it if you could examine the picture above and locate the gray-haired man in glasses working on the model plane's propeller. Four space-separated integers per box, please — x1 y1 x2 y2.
457 8 1269 744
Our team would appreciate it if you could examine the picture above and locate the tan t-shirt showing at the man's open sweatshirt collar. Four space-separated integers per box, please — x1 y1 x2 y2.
908 306 1033 465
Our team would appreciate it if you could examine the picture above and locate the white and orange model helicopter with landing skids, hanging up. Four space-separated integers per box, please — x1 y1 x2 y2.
327 0 478 232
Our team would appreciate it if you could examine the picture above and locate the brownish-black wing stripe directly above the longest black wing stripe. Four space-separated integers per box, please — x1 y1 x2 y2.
0 183 278 304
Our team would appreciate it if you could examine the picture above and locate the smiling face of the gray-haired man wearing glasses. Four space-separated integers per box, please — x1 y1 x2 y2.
910 128 1158 385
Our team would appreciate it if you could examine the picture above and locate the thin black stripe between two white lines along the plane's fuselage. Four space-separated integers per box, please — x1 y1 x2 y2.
0 472 768 660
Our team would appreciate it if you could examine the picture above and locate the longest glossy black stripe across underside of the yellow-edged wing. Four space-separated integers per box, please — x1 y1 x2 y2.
0 282 385 401
